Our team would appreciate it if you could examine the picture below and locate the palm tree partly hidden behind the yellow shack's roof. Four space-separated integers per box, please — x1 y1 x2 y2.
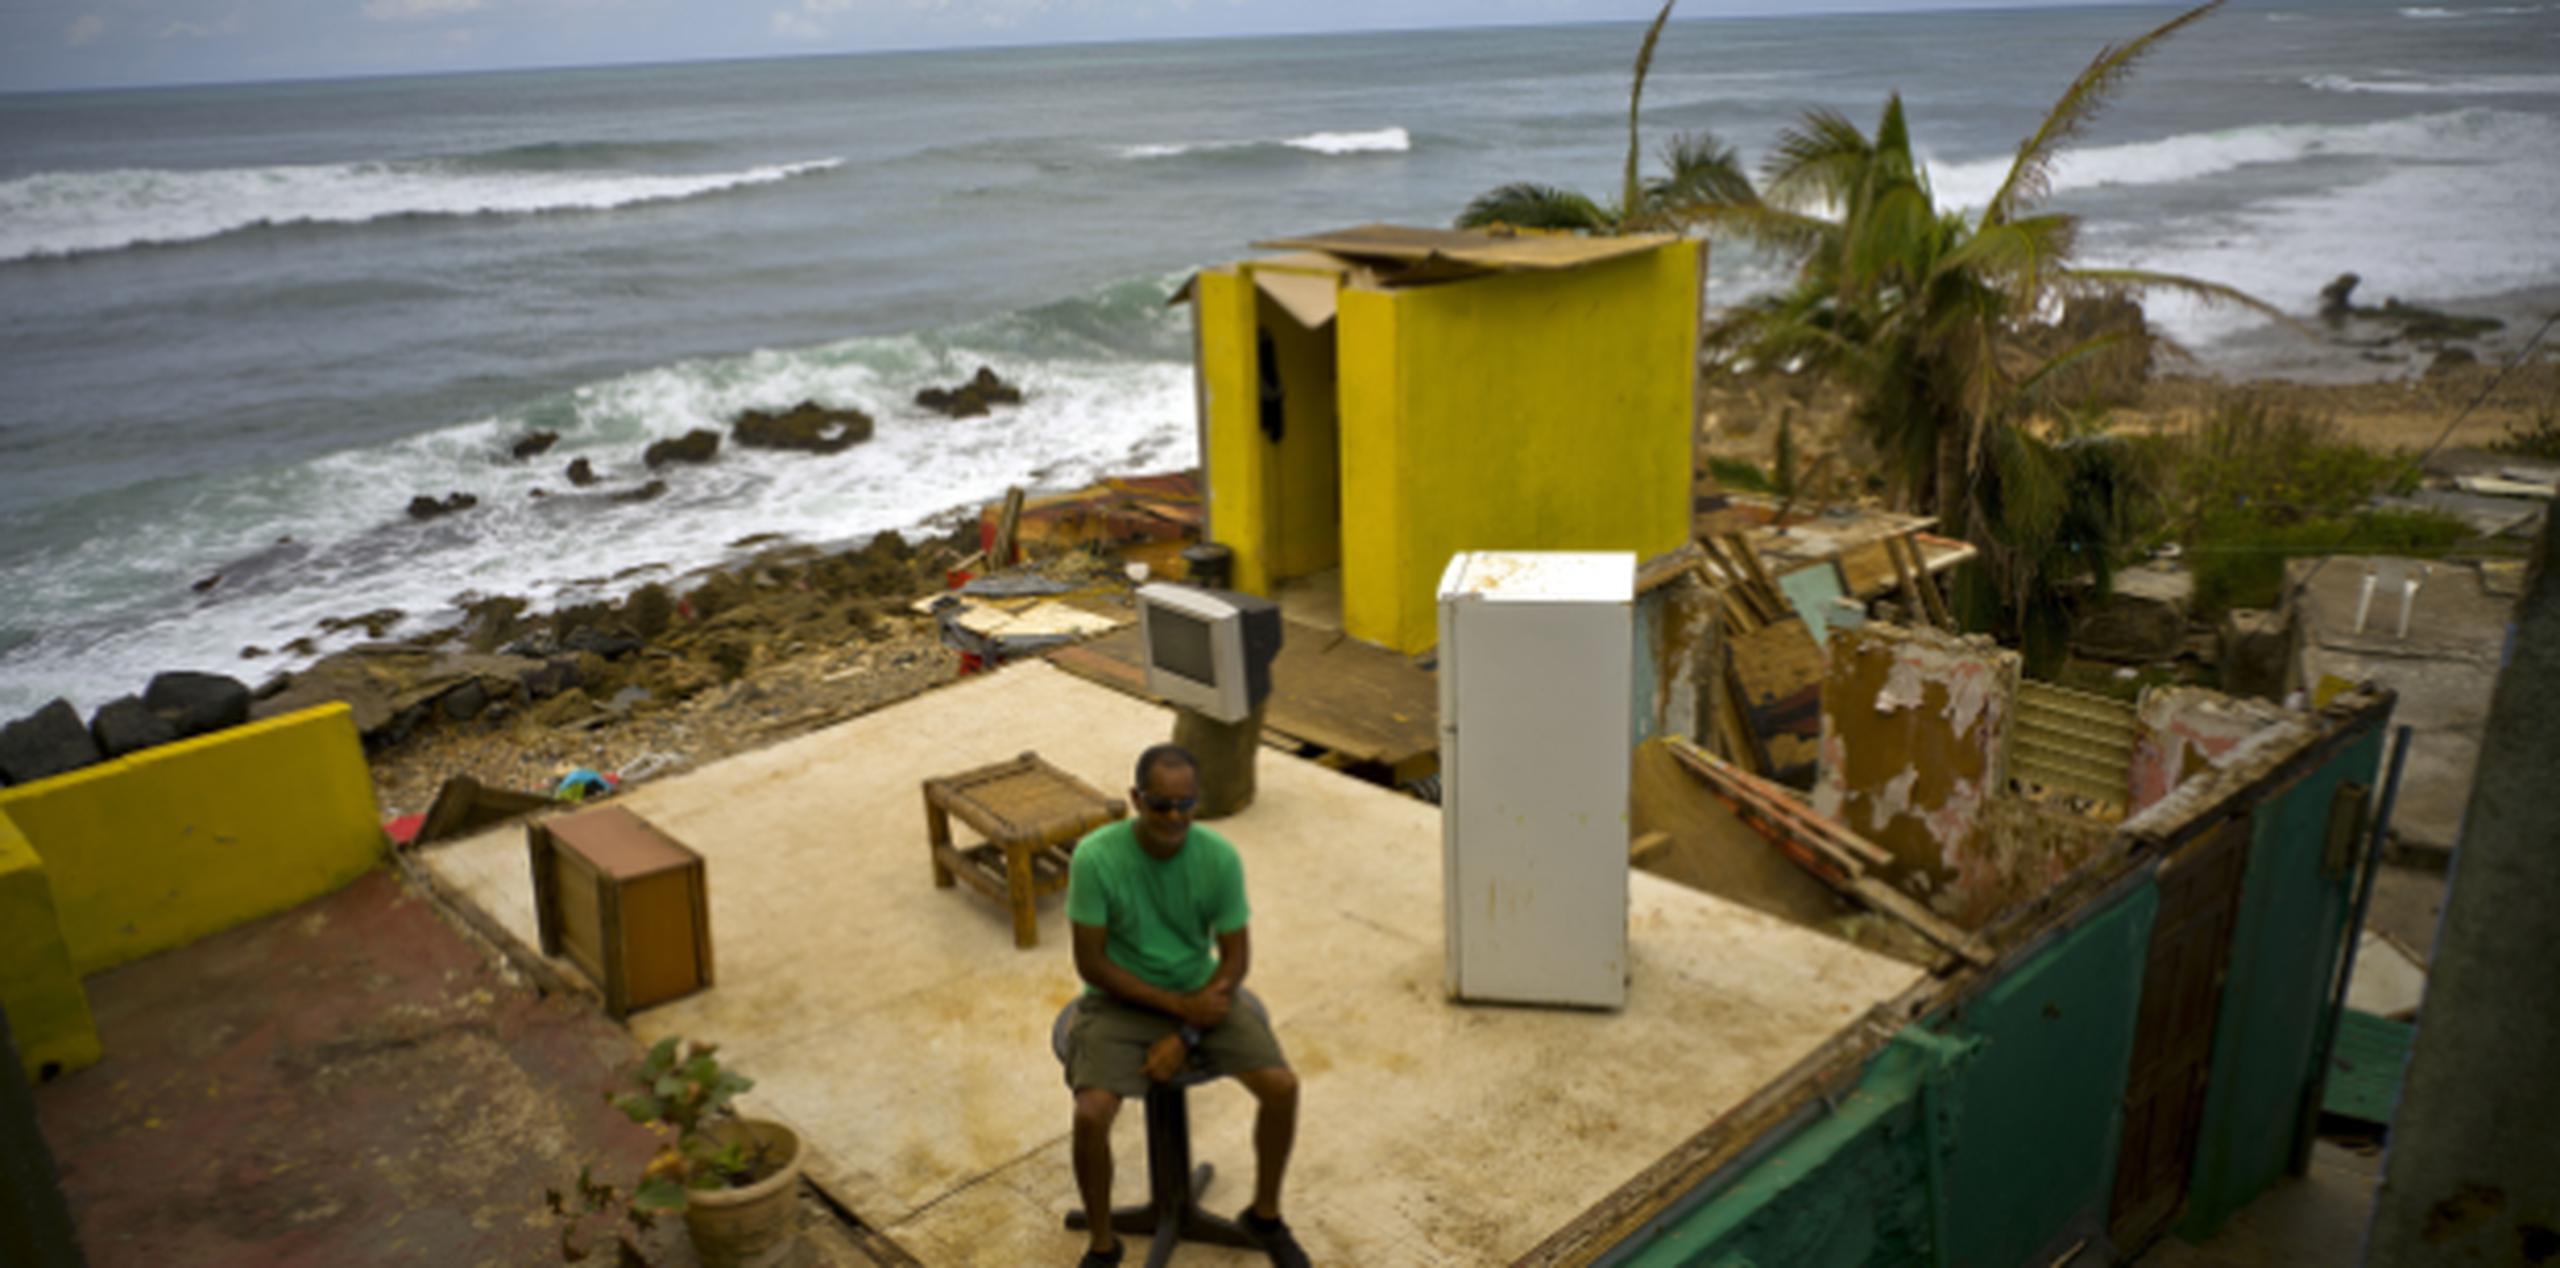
1457 0 1751 236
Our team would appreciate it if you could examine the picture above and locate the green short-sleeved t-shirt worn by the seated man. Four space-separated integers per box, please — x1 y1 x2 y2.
1068 820 1252 994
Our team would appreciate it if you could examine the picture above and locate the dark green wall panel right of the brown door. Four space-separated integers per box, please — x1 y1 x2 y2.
2179 727 2383 1237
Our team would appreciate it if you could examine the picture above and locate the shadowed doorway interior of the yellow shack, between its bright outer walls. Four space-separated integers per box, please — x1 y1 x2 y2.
1254 295 1341 581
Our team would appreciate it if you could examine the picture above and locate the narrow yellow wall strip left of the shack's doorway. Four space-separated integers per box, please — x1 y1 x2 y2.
1190 269 1272 594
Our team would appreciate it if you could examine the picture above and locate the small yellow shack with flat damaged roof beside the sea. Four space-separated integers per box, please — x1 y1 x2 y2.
1188 225 1702 653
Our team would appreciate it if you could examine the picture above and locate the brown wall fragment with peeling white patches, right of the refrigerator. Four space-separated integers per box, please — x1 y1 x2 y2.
1812 625 2020 922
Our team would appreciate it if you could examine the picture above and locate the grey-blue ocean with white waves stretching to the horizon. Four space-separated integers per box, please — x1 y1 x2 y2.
0 3 2560 717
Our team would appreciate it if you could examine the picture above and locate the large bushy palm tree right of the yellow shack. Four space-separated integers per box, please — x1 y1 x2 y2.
1661 0 2281 546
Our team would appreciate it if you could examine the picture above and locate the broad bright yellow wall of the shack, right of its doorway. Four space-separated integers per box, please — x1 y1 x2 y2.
1339 241 1697 651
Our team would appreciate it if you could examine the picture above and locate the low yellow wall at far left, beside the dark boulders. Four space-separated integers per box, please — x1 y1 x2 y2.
0 704 384 976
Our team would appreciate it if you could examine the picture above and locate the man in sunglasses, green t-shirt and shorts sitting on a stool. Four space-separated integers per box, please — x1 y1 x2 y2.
1068 743 1306 1268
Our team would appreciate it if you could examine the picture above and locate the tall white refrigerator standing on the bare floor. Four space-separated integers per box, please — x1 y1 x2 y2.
1439 551 1636 1009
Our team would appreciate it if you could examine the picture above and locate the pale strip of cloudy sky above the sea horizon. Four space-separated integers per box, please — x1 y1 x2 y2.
0 0 2140 92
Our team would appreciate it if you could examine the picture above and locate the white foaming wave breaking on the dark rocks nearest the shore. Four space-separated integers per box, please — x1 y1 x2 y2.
0 274 1198 717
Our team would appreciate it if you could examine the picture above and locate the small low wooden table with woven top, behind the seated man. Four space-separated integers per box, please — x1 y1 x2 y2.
924 753 1129 948
